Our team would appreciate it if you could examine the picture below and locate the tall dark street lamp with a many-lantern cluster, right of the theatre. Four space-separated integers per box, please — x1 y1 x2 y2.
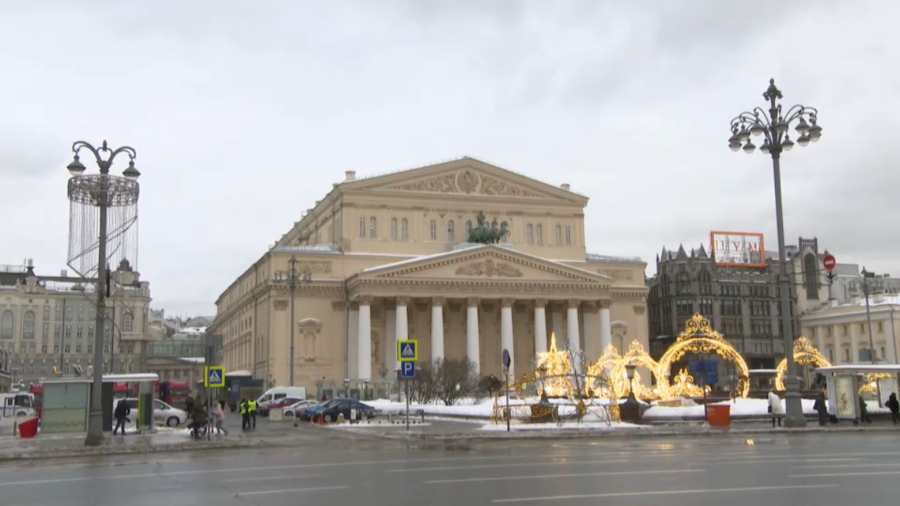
728 79 822 427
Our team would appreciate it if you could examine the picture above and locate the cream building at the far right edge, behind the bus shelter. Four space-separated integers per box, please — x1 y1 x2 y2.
800 295 900 365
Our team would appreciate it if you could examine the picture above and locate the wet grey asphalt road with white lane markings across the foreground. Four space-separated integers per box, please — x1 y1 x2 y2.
0 428 900 506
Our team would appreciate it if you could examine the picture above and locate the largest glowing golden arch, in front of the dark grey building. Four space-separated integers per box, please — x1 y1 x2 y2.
656 314 750 401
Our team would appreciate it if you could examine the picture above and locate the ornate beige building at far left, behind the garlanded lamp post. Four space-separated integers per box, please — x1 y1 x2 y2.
0 261 162 383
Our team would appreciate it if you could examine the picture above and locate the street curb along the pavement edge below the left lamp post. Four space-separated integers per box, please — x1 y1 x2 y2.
0 439 272 463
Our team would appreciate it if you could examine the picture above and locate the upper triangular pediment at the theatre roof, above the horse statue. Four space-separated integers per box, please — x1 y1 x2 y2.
342 157 587 204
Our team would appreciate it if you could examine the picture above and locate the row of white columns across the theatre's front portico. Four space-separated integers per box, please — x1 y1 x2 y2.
349 296 612 380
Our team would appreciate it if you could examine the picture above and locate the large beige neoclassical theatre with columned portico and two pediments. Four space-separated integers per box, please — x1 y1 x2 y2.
209 158 649 392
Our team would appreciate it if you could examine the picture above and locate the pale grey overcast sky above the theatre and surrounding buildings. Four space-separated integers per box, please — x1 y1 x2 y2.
0 0 900 315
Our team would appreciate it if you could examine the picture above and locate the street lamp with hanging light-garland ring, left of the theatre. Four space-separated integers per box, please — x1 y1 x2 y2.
66 141 141 446
